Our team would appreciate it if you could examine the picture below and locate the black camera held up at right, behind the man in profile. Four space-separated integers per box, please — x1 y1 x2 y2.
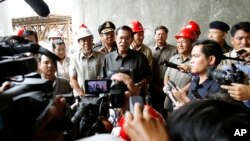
207 64 244 85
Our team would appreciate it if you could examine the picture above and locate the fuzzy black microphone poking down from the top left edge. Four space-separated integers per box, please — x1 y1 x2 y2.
24 0 50 17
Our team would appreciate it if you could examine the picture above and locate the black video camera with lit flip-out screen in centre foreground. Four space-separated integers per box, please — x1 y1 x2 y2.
68 69 132 138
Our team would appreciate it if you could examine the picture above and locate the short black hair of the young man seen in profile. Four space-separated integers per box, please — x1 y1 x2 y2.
193 39 223 67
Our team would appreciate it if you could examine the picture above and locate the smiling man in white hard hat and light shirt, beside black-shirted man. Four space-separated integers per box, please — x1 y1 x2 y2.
69 27 105 97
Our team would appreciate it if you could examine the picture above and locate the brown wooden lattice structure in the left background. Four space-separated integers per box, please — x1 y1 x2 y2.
12 15 72 47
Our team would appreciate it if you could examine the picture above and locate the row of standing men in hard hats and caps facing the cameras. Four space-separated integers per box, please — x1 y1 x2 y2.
13 21 250 115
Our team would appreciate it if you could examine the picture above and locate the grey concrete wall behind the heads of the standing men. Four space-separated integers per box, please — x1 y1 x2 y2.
80 0 250 44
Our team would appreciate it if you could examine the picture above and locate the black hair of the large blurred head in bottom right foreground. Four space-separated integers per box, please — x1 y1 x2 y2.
167 100 250 141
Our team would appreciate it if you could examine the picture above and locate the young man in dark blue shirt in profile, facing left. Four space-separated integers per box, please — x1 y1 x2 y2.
174 40 222 104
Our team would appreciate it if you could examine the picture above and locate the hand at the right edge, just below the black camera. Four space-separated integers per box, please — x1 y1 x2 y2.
221 83 250 101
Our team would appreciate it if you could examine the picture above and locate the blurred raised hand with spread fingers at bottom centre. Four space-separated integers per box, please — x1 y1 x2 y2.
124 103 169 141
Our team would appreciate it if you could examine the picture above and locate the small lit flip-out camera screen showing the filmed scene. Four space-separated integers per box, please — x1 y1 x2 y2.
84 80 111 94
